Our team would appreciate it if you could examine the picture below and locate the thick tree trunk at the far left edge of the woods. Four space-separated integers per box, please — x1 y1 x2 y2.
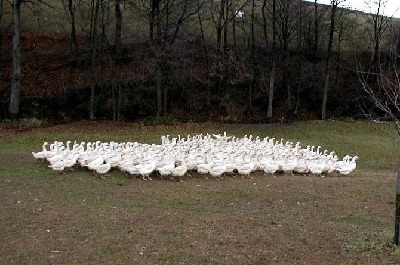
8 0 21 119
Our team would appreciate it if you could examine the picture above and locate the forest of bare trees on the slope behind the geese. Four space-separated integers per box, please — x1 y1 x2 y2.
0 0 400 122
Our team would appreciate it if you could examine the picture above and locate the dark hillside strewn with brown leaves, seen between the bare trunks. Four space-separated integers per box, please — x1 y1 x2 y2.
0 1 400 122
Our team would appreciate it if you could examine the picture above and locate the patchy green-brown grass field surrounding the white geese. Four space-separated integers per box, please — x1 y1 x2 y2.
0 121 400 264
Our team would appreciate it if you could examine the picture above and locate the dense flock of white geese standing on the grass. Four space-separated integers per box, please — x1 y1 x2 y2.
32 133 358 180
